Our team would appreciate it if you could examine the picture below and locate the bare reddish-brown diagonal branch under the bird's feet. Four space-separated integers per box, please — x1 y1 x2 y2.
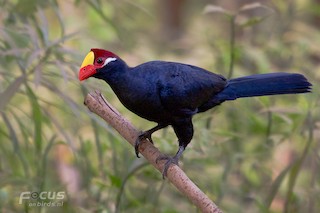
84 91 222 213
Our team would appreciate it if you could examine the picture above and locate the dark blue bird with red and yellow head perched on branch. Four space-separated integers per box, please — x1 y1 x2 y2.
78 48 312 178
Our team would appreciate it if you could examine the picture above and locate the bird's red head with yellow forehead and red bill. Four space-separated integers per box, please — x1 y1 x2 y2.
79 49 120 81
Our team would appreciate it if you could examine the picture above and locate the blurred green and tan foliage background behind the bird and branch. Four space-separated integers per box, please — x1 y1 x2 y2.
0 0 320 213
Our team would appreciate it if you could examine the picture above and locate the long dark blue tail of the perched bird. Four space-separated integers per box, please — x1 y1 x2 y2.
214 73 312 102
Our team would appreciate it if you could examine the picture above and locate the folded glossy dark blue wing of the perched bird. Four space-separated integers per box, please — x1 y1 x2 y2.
158 63 226 116
